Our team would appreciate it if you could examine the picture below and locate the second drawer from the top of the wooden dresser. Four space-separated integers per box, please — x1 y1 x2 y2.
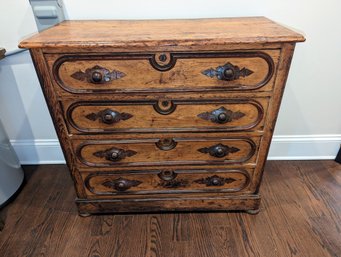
64 98 268 134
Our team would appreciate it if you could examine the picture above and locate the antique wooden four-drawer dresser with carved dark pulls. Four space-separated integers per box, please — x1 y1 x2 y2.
20 17 304 216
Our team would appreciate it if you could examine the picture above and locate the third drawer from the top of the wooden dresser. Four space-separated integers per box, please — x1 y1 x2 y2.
73 135 260 167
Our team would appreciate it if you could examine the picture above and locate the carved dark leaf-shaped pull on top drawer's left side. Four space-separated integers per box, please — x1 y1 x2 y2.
71 65 126 84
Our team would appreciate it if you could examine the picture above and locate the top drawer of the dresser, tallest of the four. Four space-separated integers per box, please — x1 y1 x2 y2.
45 50 279 94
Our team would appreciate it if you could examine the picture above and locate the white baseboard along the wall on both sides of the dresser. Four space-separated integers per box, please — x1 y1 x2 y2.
11 135 341 164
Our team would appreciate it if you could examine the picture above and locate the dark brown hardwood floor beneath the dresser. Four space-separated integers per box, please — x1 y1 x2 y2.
0 161 341 257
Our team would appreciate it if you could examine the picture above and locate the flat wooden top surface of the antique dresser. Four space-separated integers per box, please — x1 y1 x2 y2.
19 17 305 48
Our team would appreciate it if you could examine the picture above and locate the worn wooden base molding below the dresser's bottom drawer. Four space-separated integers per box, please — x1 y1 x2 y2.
76 194 261 214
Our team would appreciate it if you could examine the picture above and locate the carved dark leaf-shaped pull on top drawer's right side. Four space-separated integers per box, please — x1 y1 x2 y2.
202 62 253 81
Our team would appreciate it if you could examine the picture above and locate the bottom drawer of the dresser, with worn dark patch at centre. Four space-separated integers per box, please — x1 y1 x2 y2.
81 169 252 197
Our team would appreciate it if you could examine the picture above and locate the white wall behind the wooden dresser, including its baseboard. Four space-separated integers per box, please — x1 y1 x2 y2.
0 0 341 163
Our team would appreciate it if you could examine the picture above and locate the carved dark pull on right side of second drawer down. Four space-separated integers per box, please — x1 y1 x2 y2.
198 106 245 124
